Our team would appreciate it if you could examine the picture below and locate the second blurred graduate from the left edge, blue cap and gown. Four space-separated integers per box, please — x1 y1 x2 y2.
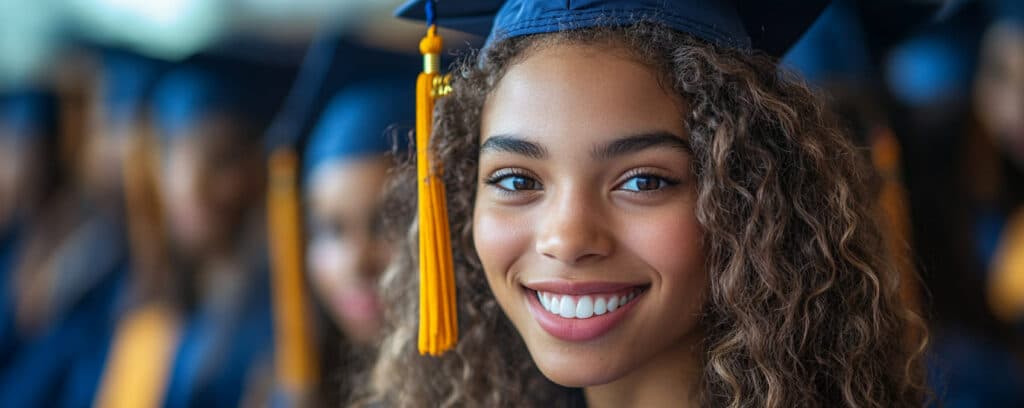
0 50 159 406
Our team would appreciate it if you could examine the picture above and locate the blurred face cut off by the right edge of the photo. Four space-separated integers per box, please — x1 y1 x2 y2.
975 23 1024 168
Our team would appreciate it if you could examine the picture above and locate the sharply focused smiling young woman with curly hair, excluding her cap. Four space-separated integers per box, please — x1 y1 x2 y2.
358 2 925 407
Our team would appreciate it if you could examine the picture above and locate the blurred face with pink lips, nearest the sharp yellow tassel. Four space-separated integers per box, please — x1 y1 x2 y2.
307 158 391 344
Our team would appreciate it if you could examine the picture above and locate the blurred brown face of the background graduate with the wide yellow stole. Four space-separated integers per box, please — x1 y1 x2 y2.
161 120 263 256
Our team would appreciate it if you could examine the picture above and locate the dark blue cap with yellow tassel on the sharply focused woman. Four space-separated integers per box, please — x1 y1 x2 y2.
396 0 827 356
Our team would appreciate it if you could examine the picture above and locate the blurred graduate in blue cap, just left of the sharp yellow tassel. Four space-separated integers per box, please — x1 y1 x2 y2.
303 78 415 405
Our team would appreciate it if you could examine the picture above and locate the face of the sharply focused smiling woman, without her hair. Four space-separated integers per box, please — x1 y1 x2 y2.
473 45 708 386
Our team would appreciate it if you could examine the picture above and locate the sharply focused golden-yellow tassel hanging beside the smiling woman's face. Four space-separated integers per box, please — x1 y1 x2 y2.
416 26 459 356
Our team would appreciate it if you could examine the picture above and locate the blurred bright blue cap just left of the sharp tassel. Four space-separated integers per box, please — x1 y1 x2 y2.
303 79 416 176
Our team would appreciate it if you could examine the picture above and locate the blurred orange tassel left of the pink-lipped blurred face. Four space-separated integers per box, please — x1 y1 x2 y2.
267 148 319 397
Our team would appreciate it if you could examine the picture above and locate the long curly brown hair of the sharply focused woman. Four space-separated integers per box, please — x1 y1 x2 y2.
365 23 927 407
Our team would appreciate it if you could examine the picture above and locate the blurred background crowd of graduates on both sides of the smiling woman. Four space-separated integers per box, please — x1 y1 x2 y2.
0 0 1024 407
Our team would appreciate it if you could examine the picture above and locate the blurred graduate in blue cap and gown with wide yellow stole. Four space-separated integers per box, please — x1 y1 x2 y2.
95 62 281 407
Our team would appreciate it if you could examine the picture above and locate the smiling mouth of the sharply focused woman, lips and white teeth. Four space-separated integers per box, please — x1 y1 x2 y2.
525 282 646 341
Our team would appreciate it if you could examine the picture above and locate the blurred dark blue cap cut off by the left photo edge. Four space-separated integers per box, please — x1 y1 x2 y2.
0 88 57 140
